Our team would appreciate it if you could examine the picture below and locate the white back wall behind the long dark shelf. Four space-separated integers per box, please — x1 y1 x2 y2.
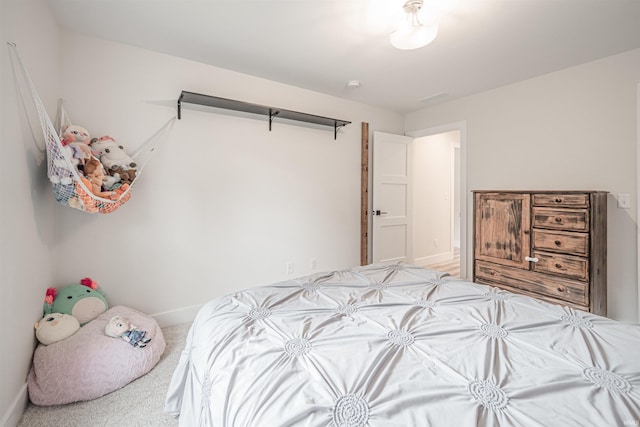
54 33 404 324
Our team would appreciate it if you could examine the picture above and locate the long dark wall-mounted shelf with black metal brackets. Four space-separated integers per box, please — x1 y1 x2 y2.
178 90 351 139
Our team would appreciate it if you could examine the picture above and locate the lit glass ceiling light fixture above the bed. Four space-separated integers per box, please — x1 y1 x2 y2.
390 0 438 50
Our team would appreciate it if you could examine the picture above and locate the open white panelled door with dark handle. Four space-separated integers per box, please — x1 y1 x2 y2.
372 132 413 263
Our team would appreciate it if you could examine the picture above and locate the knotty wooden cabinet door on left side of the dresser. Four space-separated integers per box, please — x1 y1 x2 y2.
474 193 531 270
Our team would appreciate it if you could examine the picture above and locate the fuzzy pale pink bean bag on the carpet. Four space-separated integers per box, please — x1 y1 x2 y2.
27 306 165 406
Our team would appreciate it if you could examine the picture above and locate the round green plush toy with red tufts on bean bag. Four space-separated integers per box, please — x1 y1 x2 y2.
44 277 109 326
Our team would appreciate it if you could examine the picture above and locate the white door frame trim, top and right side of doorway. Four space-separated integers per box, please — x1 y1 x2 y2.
405 120 471 279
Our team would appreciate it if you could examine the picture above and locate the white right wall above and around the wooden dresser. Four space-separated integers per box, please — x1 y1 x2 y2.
406 50 640 321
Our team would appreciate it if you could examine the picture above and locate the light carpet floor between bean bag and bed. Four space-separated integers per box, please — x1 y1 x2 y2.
18 323 191 427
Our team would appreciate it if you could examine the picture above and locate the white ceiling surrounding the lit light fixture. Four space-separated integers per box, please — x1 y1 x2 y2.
48 0 640 113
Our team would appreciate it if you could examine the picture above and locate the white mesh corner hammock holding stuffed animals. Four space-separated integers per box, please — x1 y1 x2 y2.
9 43 175 214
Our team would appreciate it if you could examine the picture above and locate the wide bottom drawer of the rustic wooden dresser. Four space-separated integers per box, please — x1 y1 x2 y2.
475 261 589 305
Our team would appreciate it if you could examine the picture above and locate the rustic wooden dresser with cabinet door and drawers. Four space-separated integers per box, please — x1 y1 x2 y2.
473 191 607 316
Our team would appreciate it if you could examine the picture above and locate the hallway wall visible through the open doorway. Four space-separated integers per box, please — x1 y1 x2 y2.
413 131 459 265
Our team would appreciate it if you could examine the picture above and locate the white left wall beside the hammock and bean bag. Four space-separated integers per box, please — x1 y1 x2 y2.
0 0 59 426
